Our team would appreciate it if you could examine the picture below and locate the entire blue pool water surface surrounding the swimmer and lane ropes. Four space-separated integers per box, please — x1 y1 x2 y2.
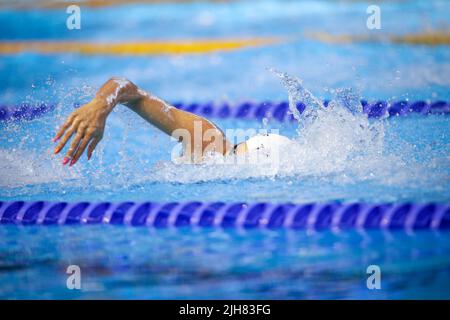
0 1 450 299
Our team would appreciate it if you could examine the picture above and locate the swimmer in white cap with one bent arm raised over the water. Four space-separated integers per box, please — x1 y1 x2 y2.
53 78 290 166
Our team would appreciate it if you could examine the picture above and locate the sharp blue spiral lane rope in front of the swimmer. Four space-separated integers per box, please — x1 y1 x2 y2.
0 201 450 230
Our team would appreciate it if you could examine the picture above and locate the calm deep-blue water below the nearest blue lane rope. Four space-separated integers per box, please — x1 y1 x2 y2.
0 226 450 299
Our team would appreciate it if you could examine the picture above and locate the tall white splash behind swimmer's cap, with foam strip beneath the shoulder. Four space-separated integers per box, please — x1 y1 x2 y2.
153 69 441 191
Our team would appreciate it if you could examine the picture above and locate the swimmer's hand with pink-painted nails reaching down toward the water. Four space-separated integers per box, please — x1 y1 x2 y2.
53 98 107 166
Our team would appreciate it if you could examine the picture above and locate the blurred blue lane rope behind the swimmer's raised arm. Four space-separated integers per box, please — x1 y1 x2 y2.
0 100 450 122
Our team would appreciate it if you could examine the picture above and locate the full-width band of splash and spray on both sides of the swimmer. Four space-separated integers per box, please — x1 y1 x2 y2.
0 70 449 199
